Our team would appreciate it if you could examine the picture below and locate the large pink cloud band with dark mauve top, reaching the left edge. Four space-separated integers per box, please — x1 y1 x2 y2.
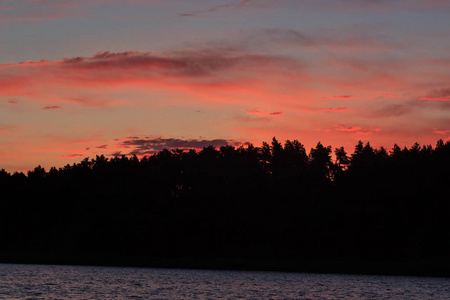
0 49 304 106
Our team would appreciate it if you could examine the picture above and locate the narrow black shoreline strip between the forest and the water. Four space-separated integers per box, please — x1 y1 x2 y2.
0 253 450 277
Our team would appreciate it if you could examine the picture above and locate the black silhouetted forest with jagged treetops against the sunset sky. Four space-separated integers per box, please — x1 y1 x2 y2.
0 138 450 271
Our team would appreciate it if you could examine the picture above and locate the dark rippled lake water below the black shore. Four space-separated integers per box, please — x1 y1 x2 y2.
0 264 450 299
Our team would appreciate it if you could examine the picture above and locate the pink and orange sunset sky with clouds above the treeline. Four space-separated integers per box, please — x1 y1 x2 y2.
0 0 450 172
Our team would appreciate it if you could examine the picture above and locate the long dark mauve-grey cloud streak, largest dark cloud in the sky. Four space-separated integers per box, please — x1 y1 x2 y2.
63 47 303 79
